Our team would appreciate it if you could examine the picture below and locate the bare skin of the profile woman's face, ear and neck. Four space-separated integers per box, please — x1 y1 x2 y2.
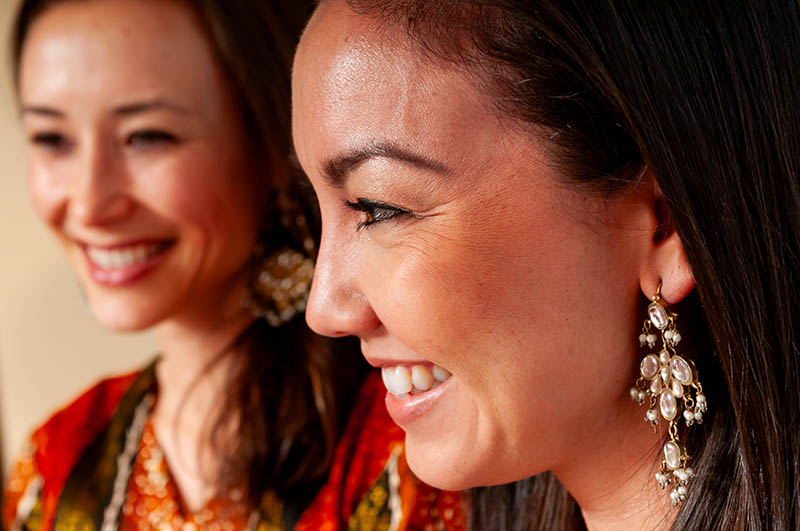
293 0 693 529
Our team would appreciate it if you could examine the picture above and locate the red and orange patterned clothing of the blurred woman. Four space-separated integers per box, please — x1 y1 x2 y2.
2 364 466 531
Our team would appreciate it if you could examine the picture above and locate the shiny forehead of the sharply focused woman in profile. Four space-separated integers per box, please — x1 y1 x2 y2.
293 0 501 171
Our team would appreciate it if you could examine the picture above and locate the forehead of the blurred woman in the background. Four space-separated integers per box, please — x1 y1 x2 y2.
20 0 218 107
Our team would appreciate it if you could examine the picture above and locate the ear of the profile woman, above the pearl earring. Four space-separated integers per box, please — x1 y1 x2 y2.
639 169 695 304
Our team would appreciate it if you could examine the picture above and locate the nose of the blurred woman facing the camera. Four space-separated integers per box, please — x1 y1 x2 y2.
67 138 133 226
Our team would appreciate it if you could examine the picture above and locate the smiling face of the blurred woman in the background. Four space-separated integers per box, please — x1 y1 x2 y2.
19 0 264 329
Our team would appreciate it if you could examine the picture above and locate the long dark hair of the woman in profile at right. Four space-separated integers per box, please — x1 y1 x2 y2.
348 0 800 531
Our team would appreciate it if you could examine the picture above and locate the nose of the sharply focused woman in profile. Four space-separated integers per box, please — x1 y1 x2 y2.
306 229 381 337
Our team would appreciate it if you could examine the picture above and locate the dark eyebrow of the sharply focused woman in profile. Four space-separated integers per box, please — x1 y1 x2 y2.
322 142 450 188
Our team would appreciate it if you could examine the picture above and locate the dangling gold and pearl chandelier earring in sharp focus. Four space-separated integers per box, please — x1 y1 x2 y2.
630 282 708 505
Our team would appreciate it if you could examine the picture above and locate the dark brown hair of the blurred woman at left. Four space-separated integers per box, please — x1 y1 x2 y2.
12 0 363 503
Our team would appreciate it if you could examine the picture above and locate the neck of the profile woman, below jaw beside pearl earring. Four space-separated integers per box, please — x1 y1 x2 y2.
554 396 674 531
